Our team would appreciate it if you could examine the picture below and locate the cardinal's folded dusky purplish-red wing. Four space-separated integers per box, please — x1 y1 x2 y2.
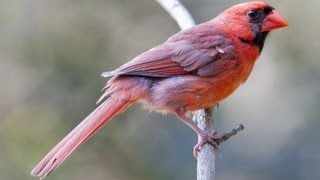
102 28 234 77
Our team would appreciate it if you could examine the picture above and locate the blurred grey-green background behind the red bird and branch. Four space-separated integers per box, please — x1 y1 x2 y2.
0 0 320 180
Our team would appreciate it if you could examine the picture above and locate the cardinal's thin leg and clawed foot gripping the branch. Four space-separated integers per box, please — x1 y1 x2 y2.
176 111 220 157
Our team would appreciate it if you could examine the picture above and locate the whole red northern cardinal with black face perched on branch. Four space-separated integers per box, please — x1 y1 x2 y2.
31 1 288 178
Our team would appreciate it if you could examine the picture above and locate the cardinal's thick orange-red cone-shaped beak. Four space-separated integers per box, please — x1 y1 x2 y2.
261 10 289 32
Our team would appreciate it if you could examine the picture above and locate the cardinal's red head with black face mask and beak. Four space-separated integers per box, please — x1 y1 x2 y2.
218 1 288 51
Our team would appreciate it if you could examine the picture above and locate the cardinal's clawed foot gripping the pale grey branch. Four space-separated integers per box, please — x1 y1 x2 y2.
193 131 222 158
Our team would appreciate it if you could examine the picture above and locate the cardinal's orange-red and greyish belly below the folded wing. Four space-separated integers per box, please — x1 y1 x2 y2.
148 71 246 111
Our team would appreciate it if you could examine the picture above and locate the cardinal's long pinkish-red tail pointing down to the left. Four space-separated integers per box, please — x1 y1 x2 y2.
31 96 132 178
